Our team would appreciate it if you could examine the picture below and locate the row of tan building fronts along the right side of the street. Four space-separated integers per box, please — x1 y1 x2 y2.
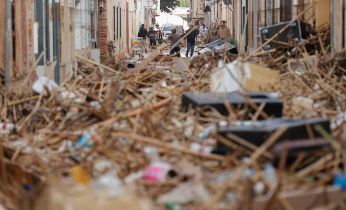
200 0 346 50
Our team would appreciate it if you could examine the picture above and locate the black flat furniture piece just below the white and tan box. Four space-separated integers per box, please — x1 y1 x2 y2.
182 92 283 119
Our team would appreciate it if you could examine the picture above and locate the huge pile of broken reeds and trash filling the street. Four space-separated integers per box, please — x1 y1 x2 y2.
0 20 346 210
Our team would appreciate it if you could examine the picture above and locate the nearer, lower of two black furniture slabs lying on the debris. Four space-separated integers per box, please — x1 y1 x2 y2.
215 118 330 154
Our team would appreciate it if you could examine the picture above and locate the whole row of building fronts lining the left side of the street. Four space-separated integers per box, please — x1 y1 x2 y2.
0 0 159 87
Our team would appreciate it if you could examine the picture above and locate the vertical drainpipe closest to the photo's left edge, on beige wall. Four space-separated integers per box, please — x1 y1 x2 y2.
4 0 12 90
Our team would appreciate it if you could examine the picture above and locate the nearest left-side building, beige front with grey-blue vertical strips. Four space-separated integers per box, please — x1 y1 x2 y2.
0 0 97 83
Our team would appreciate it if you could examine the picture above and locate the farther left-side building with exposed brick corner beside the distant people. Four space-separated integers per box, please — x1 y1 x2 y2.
99 0 159 61
